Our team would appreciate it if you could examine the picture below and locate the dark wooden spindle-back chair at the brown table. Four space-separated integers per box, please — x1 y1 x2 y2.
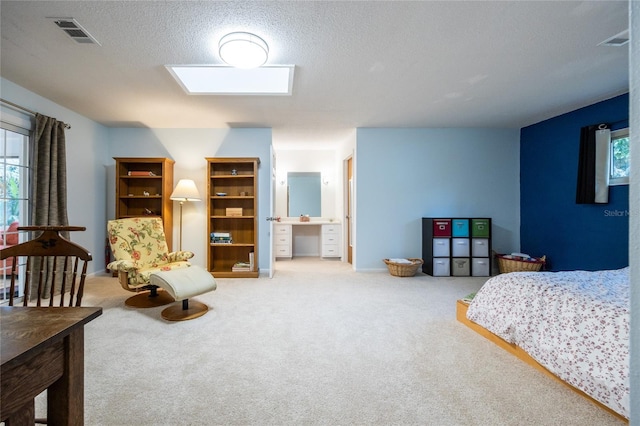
0 226 92 307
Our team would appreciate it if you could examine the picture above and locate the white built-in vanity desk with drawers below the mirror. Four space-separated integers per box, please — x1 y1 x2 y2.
273 220 342 259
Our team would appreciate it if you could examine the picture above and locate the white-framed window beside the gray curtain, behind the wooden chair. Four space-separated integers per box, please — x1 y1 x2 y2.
0 122 29 303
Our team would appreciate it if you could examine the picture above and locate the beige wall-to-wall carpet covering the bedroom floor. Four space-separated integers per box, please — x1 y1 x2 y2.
36 258 623 426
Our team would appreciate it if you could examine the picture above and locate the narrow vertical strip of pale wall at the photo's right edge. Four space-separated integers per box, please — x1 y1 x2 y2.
629 1 640 426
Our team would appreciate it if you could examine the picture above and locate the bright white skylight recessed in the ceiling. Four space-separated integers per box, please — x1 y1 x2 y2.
167 65 295 96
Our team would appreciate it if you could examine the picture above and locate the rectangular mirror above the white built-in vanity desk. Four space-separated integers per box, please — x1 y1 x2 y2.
287 172 322 217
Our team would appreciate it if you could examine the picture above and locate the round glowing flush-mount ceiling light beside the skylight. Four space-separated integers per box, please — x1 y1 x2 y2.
218 32 269 68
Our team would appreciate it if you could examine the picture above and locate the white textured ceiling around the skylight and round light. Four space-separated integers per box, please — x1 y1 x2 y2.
0 0 628 149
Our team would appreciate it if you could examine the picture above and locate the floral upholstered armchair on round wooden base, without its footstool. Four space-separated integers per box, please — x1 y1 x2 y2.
107 217 193 307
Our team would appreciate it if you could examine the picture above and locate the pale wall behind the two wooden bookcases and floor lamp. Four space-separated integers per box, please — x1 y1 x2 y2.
107 128 271 273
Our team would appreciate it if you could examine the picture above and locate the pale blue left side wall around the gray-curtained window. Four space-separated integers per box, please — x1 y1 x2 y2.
0 78 109 273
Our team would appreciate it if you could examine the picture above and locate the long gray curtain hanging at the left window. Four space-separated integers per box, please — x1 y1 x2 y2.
29 114 69 295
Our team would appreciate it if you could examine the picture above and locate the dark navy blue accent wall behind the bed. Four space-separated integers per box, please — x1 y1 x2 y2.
520 94 629 271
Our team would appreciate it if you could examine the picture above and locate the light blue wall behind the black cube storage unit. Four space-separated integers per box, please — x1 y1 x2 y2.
354 128 520 271
